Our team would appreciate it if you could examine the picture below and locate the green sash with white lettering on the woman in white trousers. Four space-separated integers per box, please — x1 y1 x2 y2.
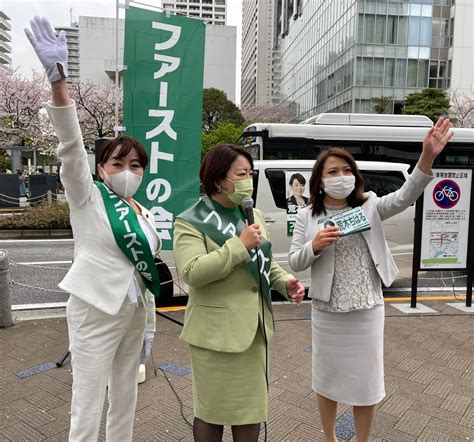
94 181 160 297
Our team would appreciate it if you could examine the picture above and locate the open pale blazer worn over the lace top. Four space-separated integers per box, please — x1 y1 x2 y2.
288 167 433 302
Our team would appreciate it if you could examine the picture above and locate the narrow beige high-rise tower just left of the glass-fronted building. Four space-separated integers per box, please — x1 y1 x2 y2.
241 0 277 108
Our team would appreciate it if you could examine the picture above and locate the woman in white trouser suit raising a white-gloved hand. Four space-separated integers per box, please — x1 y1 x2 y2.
25 17 160 441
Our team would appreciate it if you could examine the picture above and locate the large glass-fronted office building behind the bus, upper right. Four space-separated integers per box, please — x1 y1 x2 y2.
273 0 454 120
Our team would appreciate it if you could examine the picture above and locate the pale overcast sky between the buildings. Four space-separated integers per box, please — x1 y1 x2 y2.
0 0 242 103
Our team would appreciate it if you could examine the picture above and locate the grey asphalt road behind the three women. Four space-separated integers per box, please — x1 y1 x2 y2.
0 239 466 306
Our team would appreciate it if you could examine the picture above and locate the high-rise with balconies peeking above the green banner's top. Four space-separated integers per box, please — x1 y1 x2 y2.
163 0 227 25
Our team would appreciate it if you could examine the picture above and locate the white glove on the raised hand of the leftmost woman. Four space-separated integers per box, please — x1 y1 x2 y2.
25 16 67 83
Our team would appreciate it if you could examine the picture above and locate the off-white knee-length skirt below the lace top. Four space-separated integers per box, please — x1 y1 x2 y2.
311 304 385 406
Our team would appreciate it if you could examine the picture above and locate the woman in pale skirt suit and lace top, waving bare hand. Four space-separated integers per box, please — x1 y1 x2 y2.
288 118 452 442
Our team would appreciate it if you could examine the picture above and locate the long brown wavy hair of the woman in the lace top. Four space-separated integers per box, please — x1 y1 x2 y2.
309 147 367 216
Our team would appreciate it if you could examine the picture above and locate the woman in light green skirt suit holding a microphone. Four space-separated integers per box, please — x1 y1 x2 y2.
174 144 304 442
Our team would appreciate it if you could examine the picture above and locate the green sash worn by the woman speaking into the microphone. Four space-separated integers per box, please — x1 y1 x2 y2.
179 196 272 310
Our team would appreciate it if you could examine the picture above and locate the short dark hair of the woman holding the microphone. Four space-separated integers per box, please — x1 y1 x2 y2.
199 144 253 196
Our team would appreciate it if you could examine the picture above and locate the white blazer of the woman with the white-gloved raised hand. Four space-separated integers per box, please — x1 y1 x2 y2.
45 103 161 318
